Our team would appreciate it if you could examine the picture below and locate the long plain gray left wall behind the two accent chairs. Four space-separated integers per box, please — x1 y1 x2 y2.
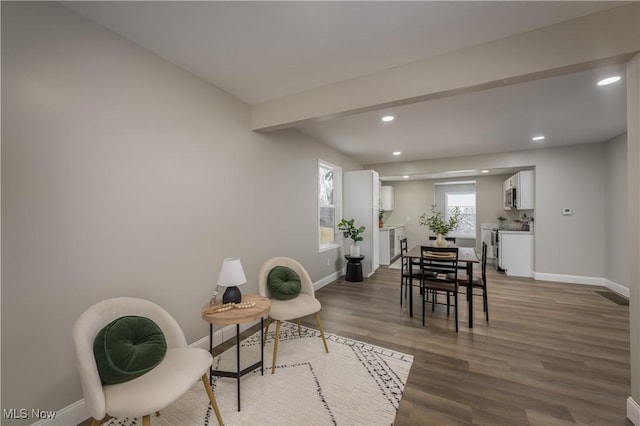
1 2 361 422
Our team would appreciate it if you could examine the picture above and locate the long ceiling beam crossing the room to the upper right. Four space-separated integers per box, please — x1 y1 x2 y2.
251 3 640 132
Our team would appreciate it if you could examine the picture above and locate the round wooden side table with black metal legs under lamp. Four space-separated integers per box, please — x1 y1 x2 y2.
201 294 271 411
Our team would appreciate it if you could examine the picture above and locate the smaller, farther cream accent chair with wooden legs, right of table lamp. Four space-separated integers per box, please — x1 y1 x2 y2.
258 257 329 374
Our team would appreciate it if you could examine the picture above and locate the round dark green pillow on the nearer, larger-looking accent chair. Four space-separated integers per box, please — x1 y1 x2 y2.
93 316 167 385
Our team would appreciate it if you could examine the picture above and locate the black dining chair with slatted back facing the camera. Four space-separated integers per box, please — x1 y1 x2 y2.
420 246 459 333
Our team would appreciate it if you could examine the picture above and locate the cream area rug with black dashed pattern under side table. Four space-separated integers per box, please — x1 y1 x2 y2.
108 323 413 426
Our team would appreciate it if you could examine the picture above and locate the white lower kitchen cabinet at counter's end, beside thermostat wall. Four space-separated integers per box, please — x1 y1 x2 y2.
498 230 534 277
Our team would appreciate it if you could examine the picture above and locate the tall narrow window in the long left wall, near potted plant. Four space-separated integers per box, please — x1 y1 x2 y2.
318 160 342 252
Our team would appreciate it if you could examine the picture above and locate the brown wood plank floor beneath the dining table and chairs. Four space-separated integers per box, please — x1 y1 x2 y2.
303 267 632 426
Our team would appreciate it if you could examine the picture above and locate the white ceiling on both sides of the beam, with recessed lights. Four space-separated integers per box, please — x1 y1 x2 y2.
63 1 628 175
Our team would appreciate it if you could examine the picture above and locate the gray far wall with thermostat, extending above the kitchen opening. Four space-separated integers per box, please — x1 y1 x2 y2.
365 143 628 287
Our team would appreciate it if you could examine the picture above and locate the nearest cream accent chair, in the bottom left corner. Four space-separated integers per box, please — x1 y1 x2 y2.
73 297 223 426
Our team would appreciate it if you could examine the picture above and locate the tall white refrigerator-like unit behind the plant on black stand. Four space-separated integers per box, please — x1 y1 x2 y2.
342 170 380 277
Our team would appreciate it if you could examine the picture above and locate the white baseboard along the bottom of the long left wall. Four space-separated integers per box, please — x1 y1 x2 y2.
42 271 344 426
